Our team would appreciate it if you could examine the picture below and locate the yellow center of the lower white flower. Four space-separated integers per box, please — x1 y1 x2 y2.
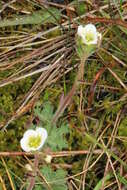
28 135 41 148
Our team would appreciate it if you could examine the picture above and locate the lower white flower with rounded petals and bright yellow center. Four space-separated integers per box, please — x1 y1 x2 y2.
20 127 47 152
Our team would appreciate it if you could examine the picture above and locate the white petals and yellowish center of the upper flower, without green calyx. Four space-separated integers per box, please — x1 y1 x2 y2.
77 24 101 45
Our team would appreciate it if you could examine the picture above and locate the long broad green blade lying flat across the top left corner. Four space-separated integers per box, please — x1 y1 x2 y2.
0 7 61 27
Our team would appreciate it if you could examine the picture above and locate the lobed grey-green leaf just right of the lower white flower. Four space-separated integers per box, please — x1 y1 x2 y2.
34 102 69 151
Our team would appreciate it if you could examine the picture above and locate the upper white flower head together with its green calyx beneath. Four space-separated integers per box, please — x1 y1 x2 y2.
76 24 102 57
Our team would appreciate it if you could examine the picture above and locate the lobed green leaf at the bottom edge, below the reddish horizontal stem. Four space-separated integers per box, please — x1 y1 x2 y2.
41 166 67 190
